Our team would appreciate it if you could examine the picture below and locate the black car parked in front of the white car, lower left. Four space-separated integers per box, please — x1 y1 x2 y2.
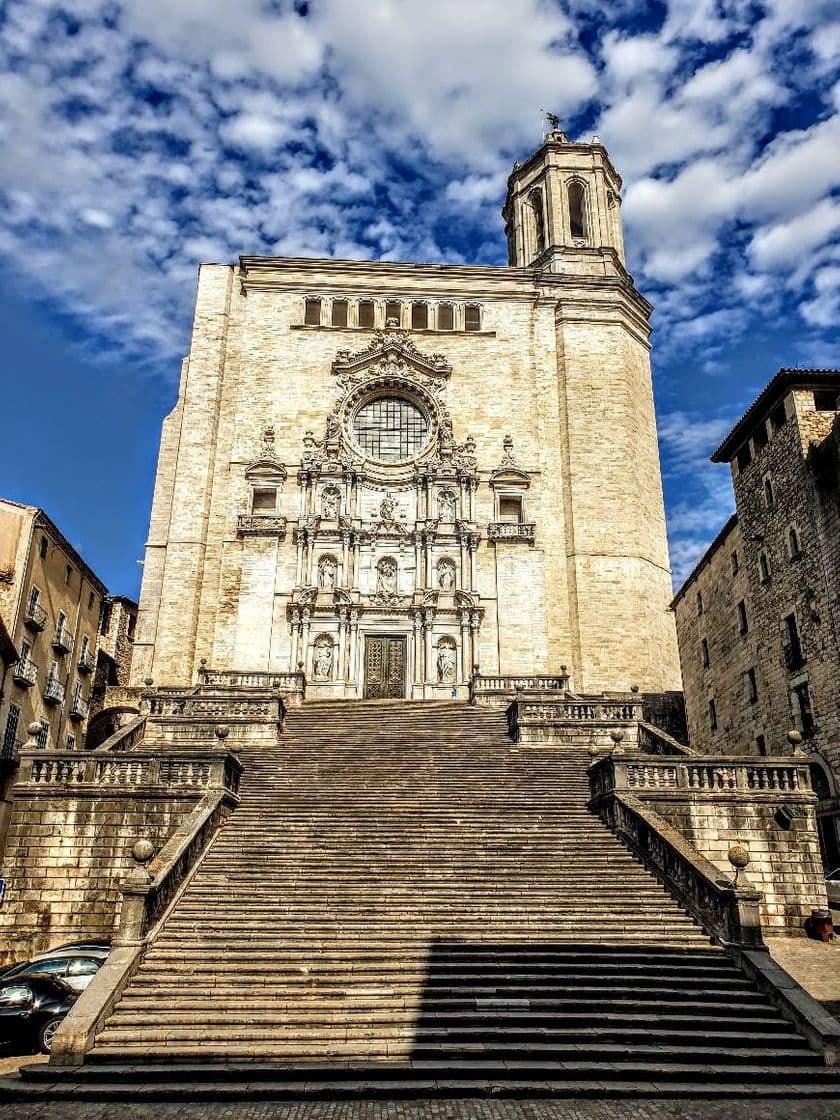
0 973 78 1054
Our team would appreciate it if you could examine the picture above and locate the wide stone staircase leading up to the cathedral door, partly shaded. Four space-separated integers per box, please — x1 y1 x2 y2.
28 701 840 1099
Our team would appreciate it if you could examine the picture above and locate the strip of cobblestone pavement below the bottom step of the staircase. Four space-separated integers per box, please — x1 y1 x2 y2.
0 1100 840 1120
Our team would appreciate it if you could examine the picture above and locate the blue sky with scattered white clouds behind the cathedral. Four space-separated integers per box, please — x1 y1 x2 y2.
0 0 840 595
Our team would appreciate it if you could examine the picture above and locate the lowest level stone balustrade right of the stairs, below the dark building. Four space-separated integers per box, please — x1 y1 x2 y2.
589 754 811 797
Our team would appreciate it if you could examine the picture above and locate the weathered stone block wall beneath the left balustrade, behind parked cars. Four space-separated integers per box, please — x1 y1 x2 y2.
0 791 195 965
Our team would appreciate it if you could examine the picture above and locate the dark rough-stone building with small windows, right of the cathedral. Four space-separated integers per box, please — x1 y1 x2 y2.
674 370 840 869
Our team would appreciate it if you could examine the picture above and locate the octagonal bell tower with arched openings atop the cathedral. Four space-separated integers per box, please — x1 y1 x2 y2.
502 129 624 272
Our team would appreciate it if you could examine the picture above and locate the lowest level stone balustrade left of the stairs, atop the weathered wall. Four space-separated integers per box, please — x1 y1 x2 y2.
19 750 242 794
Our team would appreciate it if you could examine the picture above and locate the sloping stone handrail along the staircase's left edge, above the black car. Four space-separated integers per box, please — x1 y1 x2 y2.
49 790 236 1065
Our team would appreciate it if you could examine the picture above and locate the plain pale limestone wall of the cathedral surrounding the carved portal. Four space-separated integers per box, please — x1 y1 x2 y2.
132 253 679 691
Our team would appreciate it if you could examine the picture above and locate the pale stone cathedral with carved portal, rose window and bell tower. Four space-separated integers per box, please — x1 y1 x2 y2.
132 131 680 699
